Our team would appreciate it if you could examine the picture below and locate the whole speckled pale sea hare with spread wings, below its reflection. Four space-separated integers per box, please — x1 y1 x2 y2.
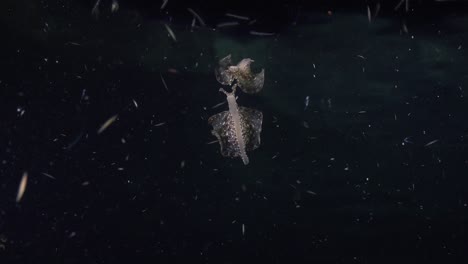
208 84 263 165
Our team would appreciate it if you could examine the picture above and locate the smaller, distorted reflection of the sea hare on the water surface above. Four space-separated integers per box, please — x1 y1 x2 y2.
215 55 265 94
